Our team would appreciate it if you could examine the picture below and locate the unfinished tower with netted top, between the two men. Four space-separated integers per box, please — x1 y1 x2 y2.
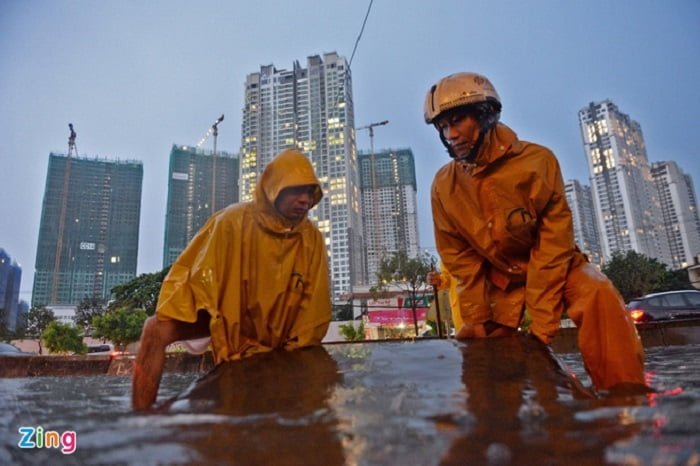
359 149 420 284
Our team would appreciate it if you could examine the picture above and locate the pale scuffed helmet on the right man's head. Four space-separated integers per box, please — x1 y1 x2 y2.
424 73 501 124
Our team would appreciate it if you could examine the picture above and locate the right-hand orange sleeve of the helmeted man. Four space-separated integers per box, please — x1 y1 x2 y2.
525 154 574 342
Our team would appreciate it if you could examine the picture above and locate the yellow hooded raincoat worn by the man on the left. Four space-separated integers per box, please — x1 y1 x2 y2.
156 150 331 364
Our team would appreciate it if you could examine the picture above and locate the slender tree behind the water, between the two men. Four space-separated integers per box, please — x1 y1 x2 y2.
377 250 433 336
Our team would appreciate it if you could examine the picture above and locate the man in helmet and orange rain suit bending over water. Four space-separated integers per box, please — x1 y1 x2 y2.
425 73 644 390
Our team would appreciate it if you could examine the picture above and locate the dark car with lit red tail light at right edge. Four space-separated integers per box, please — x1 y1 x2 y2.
627 290 700 323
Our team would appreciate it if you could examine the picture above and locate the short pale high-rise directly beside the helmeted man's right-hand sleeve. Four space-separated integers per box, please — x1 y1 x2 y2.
564 180 602 266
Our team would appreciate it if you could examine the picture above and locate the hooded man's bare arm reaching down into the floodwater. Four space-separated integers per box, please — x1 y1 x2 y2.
131 312 209 411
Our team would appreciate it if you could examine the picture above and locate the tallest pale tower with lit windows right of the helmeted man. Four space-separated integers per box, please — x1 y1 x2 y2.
578 100 671 265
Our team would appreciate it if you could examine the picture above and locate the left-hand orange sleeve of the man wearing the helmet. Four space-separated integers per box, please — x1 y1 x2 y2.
431 180 491 325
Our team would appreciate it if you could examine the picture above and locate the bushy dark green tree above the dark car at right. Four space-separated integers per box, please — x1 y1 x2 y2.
603 250 666 302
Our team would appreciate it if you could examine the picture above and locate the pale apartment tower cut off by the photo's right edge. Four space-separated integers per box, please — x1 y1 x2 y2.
651 161 700 269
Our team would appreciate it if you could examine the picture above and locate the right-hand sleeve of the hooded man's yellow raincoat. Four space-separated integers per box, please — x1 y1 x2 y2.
285 230 331 350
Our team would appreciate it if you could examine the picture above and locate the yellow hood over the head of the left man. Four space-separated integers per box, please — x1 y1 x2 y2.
254 149 323 230
